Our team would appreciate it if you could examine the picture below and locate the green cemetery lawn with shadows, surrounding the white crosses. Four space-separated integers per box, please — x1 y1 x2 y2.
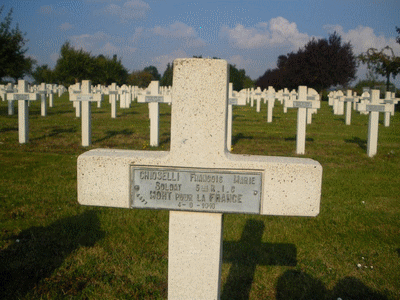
0 93 400 300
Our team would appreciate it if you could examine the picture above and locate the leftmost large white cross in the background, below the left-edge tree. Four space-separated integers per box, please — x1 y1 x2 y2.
10 80 38 144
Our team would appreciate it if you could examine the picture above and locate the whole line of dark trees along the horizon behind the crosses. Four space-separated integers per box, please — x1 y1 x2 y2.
0 6 400 91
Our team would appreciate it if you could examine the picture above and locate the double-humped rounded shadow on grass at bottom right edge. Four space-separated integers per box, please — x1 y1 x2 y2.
276 270 387 300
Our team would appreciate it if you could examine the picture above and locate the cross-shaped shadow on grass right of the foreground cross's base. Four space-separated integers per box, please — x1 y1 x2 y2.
221 220 297 299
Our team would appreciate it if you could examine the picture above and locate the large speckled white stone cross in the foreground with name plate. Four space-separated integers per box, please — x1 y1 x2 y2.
77 58 322 299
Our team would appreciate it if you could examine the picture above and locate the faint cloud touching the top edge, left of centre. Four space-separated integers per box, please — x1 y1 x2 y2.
103 0 150 22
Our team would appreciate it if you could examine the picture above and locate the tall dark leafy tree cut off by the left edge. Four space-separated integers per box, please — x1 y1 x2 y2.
0 5 31 80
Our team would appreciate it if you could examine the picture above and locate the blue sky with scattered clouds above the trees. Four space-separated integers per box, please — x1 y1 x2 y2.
1 0 400 87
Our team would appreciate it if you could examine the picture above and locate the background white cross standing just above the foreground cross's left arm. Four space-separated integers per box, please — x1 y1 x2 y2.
70 80 103 147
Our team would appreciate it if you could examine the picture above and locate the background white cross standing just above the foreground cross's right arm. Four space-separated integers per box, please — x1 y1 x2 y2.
285 85 320 154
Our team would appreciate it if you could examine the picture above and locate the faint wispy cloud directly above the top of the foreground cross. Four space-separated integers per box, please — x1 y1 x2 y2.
151 21 206 48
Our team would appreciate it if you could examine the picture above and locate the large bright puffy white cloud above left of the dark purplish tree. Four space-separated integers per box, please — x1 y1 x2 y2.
220 17 311 49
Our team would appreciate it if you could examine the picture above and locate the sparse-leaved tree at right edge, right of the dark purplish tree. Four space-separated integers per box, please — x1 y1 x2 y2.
358 46 400 90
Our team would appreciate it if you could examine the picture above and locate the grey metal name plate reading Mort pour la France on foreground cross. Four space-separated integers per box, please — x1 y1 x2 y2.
130 166 262 214
